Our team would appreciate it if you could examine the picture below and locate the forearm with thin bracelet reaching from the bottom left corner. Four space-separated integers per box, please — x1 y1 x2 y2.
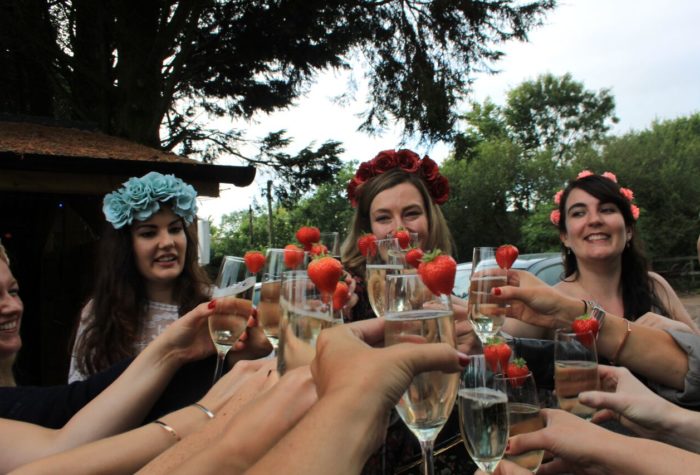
12 407 208 474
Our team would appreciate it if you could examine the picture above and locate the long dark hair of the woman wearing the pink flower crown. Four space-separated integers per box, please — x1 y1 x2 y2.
559 175 668 321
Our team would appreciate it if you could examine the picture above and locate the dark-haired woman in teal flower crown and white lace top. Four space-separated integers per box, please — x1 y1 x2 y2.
69 172 268 381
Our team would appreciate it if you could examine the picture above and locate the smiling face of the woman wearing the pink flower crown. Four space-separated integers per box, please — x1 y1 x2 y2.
560 188 632 259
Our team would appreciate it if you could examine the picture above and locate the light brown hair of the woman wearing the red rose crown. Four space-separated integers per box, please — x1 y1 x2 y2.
340 168 455 275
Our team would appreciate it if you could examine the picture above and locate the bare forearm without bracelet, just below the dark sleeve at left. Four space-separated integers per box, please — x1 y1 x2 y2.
55 343 182 451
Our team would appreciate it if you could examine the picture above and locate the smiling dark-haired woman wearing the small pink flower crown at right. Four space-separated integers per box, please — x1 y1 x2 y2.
504 170 700 338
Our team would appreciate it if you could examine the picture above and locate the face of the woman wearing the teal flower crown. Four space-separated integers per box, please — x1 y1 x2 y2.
131 206 187 284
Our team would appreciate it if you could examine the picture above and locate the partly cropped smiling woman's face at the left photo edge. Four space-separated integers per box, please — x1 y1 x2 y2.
0 260 24 358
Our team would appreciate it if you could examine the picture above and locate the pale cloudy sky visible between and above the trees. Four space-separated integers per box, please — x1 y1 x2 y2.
198 0 700 224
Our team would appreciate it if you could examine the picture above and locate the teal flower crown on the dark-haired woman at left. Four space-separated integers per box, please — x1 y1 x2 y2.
102 172 197 229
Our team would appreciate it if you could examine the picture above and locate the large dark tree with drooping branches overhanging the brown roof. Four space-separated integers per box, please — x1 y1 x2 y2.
0 0 555 156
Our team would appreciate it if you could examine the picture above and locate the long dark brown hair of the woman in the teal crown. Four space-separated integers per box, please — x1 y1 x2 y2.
75 218 210 374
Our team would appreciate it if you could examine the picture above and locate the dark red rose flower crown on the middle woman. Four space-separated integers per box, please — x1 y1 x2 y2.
347 149 450 208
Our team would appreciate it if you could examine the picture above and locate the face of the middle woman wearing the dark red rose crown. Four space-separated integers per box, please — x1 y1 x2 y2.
369 182 428 247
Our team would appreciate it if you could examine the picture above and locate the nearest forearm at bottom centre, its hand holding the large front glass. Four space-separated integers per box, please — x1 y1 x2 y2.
246 394 386 475
